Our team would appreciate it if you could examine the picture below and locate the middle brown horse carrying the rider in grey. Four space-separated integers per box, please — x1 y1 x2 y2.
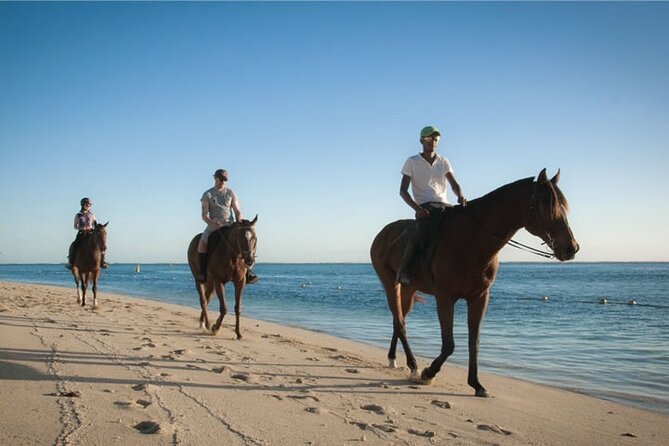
188 215 258 339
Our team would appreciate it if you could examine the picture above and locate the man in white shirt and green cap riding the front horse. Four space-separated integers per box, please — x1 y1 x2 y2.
397 126 467 285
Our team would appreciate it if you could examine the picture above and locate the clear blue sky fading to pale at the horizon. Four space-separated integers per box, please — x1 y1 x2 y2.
0 2 669 263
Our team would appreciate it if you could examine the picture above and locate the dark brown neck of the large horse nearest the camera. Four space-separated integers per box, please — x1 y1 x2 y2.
467 179 532 251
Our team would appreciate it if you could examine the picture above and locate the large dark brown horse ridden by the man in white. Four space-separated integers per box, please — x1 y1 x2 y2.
371 169 579 397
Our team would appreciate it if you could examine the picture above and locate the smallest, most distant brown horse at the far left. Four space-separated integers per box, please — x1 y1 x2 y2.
72 222 109 307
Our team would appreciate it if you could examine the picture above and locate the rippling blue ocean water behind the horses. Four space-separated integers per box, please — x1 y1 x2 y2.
0 262 669 414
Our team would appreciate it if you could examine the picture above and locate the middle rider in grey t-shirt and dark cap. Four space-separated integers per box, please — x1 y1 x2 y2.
197 169 258 283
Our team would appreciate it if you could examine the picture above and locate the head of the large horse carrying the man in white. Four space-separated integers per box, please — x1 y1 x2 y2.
525 169 579 261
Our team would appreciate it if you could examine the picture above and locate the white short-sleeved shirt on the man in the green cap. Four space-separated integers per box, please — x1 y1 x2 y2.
402 153 453 205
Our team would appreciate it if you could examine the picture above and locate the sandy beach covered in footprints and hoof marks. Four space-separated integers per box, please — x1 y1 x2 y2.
0 282 669 445
